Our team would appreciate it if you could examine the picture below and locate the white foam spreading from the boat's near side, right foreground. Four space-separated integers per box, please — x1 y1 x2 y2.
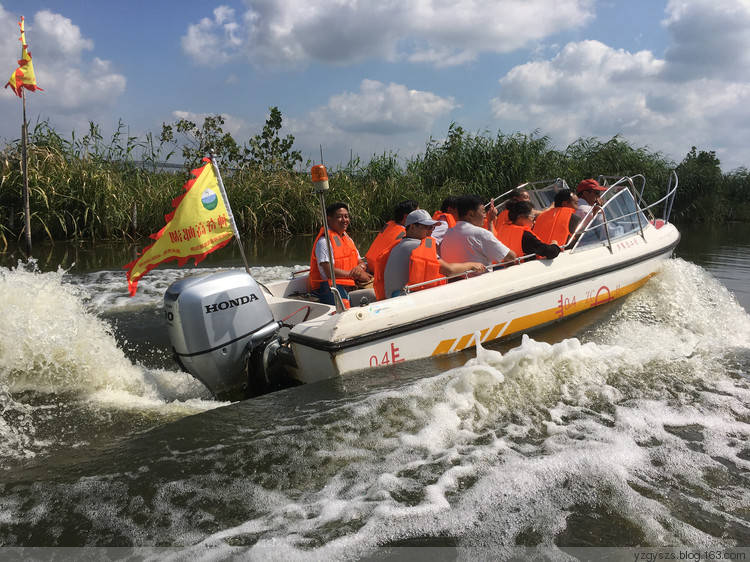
184 260 750 559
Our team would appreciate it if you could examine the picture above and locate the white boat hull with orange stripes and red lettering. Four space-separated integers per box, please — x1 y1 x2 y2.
280 224 679 383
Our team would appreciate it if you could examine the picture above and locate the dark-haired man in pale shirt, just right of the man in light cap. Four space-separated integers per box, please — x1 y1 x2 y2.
440 195 516 266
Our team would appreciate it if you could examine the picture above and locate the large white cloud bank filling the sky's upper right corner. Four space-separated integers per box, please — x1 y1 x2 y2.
491 1 750 169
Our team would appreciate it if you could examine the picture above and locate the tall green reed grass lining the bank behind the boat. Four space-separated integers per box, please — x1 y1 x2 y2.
0 122 750 249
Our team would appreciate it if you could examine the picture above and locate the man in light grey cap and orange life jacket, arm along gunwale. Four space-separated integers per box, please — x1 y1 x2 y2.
384 209 486 298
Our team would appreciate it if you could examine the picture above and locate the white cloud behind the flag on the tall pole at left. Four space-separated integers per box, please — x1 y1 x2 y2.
0 5 126 120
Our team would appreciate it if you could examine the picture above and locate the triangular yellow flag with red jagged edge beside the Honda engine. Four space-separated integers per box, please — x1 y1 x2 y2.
123 158 233 297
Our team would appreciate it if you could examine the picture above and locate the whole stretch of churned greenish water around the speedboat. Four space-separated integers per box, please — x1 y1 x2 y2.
0 222 750 560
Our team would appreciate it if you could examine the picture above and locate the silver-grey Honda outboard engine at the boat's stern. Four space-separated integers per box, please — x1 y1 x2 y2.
164 271 279 396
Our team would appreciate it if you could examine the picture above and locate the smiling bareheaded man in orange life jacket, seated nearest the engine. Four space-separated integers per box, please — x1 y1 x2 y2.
307 203 372 304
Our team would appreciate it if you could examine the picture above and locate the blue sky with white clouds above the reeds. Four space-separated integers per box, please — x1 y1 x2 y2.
0 0 750 171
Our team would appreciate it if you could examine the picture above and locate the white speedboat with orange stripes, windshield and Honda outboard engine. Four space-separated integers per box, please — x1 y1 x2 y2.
164 172 680 397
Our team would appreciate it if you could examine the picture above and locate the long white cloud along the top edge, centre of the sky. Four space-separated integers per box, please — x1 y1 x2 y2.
182 0 593 66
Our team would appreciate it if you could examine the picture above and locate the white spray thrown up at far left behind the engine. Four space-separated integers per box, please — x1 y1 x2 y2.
0 262 229 466
